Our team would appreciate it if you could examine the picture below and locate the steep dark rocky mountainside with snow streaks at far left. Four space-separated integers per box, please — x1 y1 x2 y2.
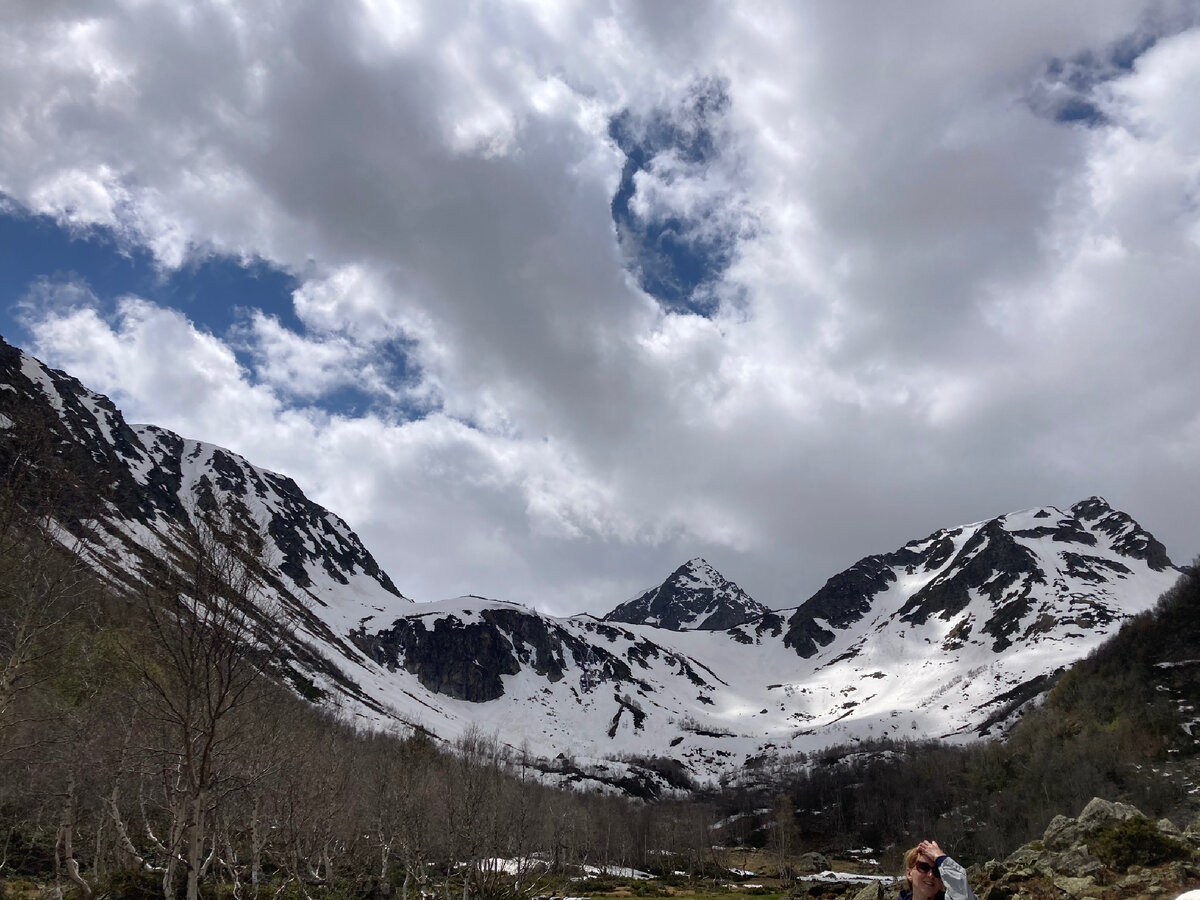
0 342 412 712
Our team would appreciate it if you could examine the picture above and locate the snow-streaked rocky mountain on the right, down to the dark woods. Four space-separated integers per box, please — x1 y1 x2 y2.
768 497 1178 736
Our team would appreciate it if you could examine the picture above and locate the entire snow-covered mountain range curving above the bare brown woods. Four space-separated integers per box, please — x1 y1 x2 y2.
0 342 1178 793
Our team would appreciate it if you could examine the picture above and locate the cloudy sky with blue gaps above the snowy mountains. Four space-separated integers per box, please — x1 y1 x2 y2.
0 0 1200 614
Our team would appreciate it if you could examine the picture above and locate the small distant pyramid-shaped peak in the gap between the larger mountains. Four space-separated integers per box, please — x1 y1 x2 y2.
604 557 770 631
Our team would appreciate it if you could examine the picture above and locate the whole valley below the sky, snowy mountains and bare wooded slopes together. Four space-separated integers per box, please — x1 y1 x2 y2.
0 338 1200 900
